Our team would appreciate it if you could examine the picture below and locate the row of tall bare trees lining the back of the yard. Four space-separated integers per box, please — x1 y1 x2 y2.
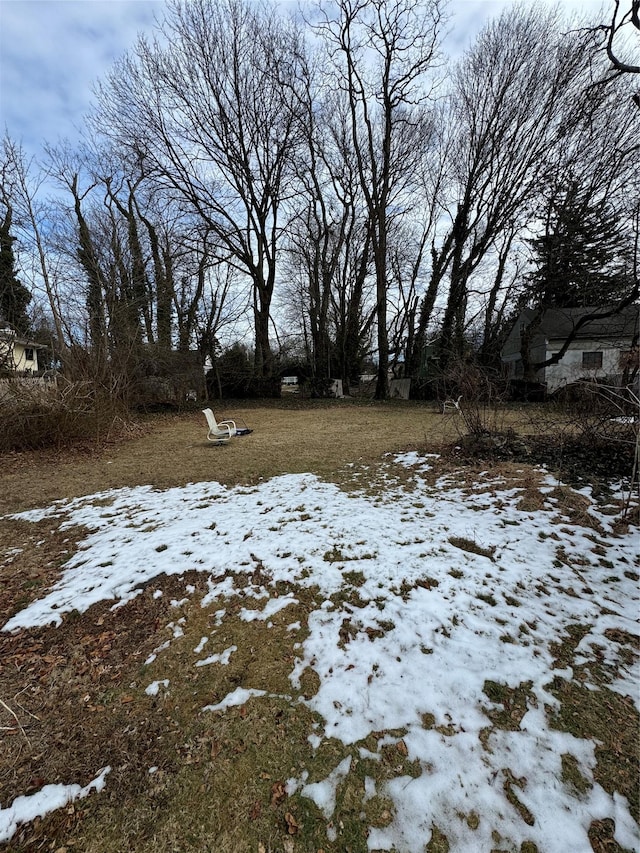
0 0 640 399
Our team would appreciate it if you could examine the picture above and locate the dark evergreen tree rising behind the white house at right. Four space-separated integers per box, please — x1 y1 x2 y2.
526 183 631 308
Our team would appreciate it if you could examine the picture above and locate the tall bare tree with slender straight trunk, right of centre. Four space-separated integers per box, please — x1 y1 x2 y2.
316 0 443 399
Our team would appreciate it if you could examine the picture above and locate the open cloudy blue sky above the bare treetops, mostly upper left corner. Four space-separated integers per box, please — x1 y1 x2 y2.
0 0 606 168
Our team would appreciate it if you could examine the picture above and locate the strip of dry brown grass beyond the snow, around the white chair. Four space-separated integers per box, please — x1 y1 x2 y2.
0 401 462 514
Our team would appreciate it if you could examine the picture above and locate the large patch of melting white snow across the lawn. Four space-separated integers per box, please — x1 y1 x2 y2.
0 450 640 853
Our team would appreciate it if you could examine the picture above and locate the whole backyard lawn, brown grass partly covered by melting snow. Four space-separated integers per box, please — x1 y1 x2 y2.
0 401 640 853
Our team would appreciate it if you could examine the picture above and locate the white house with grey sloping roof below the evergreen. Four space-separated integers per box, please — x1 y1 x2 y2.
502 305 638 394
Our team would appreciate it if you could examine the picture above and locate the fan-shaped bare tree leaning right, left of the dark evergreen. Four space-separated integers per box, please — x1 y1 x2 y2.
439 6 588 367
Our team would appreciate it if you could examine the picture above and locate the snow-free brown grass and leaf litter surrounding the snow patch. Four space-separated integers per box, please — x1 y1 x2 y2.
0 401 637 853
